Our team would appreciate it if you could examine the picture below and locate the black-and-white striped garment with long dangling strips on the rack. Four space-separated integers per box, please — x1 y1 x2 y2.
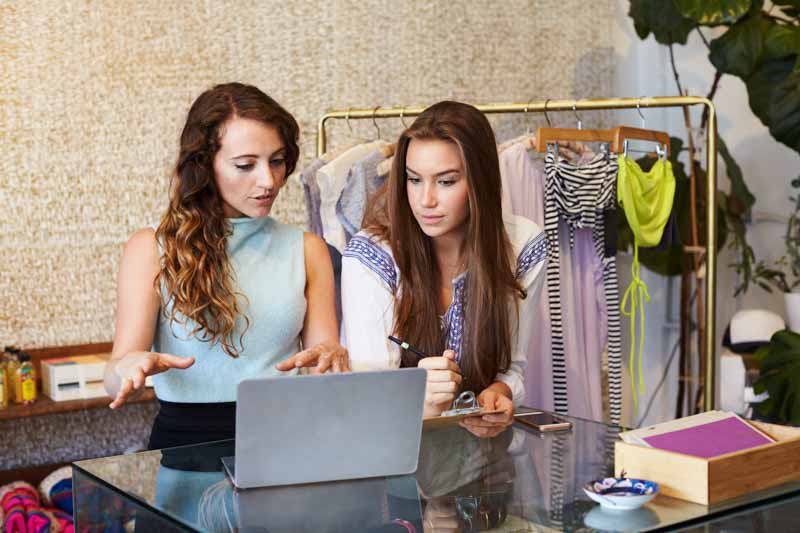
544 145 622 424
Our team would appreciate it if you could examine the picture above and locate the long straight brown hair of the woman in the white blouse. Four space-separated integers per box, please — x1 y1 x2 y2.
364 101 525 392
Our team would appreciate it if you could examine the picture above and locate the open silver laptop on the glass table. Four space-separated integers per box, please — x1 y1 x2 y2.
222 368 426 489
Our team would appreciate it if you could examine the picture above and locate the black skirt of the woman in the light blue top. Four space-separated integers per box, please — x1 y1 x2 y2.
147 400 236 450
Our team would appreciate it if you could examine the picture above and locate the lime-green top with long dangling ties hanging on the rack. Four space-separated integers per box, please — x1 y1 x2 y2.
617 154 675 409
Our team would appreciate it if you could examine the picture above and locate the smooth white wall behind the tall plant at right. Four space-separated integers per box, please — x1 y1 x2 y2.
613 0 800 424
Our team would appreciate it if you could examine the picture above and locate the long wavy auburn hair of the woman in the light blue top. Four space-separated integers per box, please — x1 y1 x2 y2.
155 83 300 357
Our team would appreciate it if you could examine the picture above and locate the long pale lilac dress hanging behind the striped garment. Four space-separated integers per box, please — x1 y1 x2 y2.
499 141 621 420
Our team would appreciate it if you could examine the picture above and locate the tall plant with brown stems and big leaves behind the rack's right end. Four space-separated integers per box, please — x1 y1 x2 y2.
619 0 800 416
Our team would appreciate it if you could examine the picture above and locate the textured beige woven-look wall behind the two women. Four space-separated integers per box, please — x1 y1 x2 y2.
0 0 613 347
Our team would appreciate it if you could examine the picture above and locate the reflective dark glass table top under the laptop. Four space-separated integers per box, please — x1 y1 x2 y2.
74 417 800 532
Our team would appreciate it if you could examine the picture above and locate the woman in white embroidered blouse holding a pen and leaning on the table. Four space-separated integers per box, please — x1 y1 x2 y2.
342 101 547 436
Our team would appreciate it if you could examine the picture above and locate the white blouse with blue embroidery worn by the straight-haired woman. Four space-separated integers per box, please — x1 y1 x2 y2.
341 215 547 405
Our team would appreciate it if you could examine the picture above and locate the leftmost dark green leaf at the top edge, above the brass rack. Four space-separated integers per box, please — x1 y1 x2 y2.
628 0 696 44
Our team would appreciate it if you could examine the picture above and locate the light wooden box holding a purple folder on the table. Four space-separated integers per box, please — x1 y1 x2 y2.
614 421 800 505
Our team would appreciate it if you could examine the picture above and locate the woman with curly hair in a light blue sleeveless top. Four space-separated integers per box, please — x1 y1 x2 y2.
105 83 349 449
